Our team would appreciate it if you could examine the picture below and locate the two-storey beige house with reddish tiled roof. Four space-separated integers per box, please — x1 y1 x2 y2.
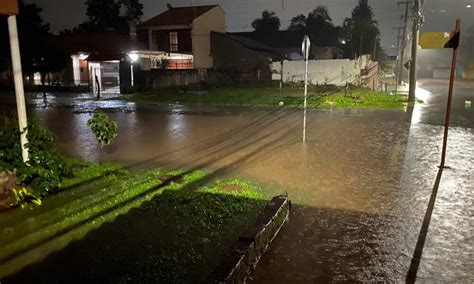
140 4 225 69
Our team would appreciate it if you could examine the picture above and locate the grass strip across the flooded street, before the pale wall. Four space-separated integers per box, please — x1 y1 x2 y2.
124 86 407 109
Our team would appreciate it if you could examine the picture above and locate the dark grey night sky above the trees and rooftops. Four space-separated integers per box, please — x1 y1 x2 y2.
27 0 474 54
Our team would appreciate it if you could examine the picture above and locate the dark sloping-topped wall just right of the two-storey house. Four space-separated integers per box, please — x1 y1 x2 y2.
211 33 270 72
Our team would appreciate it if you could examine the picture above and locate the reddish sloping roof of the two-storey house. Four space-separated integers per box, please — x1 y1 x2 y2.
141 5 219 27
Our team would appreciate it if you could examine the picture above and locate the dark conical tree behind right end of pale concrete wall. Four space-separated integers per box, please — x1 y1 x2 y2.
342 0 383 57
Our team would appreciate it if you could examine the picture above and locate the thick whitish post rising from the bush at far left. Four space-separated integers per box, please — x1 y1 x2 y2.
8 15 29 163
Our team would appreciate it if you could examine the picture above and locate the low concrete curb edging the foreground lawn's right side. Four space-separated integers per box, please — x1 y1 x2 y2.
208 196 291 283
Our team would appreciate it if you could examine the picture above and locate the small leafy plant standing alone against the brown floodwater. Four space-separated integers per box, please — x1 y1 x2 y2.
87 113 117 147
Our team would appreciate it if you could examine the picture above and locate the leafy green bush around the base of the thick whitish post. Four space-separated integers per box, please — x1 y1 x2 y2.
0 117 72 196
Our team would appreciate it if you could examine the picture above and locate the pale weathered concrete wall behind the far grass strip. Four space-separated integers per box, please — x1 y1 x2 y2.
271 56 370 86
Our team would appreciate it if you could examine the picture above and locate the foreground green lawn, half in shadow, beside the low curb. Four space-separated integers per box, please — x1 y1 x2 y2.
0 164 268 283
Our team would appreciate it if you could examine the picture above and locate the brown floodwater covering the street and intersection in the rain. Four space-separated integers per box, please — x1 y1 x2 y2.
0 78 474 283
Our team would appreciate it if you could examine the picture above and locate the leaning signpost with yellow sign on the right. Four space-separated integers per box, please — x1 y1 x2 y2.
420 19 461 168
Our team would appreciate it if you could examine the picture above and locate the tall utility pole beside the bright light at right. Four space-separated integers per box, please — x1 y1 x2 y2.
408 0 423 103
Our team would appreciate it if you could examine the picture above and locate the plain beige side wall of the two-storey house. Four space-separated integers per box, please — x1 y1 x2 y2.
191 6 225 69
